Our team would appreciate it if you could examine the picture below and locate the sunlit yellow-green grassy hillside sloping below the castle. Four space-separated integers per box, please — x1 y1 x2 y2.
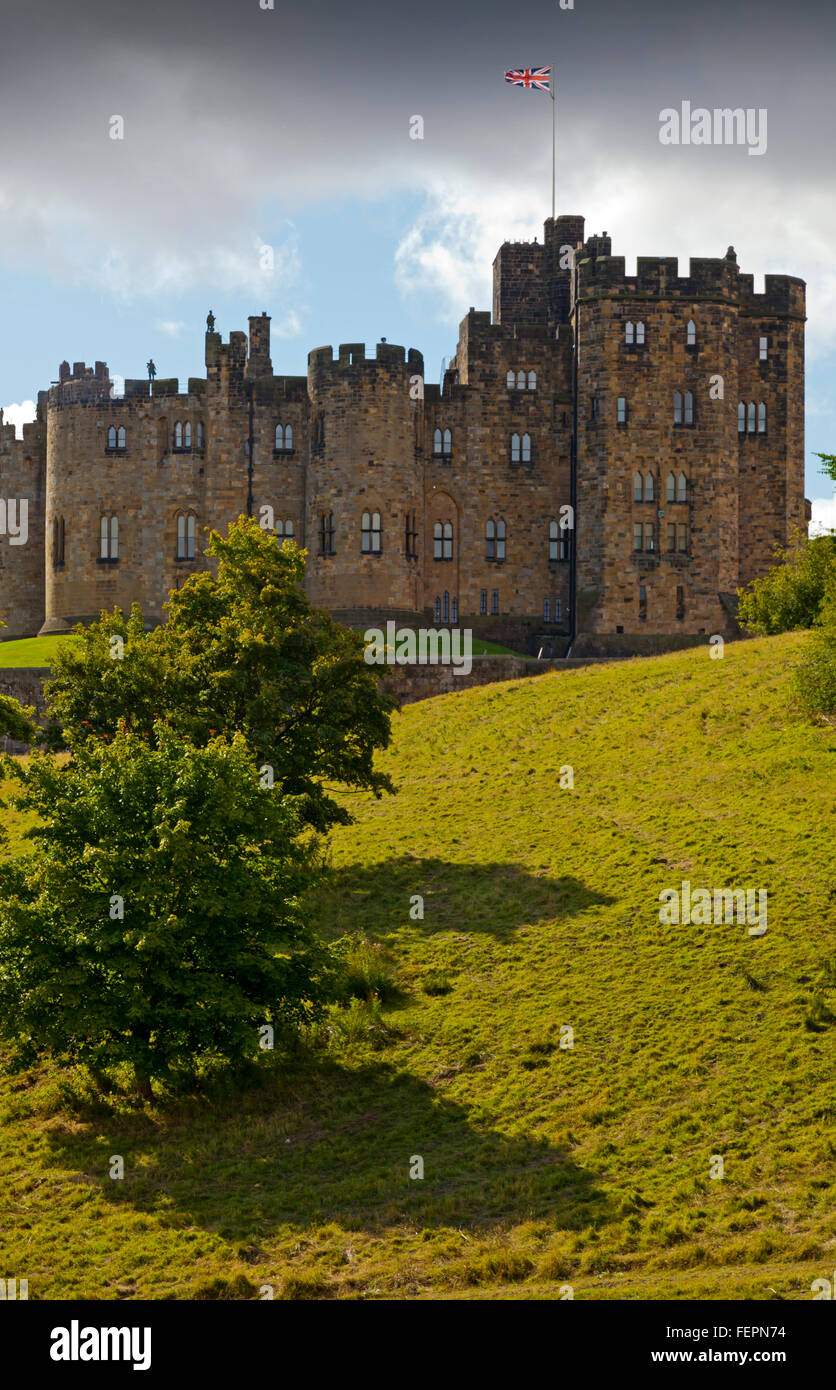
0 635 836 1298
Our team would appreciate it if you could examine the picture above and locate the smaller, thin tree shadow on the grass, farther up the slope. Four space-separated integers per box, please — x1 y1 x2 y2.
309 856 615 940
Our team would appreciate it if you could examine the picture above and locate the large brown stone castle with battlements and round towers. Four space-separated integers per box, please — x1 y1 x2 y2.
0 217 810 664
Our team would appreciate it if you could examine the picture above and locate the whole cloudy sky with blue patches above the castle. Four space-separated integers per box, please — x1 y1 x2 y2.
0 0 836 525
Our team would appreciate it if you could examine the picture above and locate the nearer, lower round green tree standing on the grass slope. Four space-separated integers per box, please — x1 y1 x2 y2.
0 721 330 1095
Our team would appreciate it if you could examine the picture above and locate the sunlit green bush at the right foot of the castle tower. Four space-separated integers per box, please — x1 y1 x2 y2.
739 532 836 637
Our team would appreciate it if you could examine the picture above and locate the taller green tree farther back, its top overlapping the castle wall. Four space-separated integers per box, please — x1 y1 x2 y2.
46 517 395 830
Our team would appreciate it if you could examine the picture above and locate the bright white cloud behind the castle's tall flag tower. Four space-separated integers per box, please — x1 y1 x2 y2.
395 152 836 364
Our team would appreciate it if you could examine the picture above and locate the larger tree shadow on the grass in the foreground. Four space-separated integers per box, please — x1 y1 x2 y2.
43 1061 606 1244
